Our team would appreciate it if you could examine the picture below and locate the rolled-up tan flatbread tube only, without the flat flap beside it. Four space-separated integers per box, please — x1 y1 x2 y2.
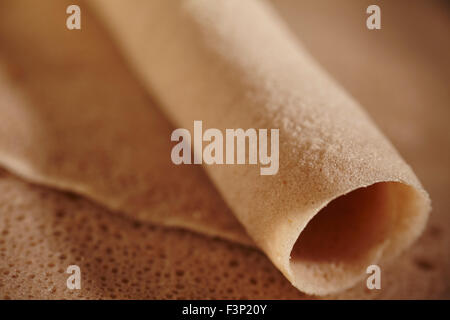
92 0 430 295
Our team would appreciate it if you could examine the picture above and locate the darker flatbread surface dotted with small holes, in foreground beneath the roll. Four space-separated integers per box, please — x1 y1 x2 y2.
0 170 448 299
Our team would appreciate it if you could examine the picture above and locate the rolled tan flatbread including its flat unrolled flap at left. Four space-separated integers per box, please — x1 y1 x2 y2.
0 1 429 294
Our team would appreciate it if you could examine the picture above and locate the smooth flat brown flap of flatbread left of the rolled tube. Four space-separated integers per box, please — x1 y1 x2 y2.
0 1 252 244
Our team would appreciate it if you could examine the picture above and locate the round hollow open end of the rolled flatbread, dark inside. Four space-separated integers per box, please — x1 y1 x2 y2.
289 182 431 295
